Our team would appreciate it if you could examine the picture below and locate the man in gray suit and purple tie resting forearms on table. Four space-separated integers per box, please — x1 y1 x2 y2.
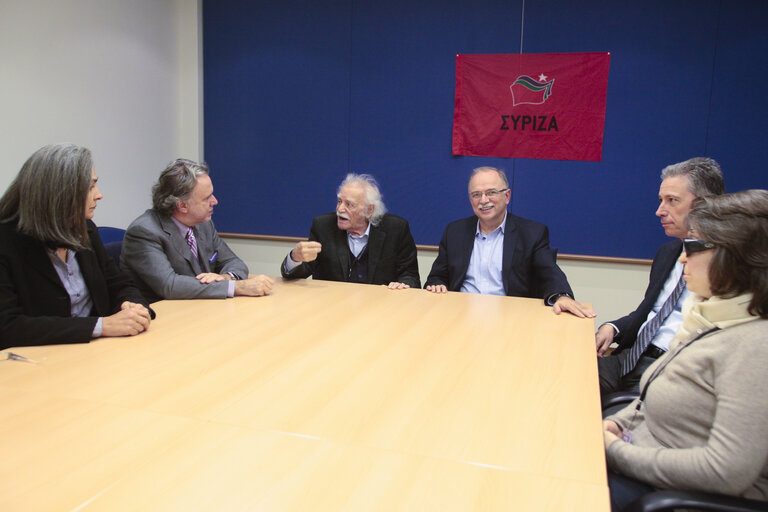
120 158 274 302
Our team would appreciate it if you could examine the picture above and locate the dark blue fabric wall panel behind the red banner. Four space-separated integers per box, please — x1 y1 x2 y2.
203 0 768 258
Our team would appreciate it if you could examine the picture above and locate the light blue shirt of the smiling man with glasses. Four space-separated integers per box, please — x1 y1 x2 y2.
461 213 507 295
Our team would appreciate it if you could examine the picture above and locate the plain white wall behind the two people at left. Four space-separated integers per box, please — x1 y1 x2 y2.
0 0 200 227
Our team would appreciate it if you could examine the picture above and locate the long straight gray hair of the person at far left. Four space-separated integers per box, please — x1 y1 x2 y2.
0 144 93 250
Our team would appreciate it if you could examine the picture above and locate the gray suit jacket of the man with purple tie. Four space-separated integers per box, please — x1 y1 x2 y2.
120 209 248 302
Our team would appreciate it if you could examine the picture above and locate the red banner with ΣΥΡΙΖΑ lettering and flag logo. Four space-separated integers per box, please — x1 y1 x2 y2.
453 53 611 161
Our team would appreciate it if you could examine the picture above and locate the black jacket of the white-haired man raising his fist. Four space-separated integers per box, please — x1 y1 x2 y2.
280 213 421 288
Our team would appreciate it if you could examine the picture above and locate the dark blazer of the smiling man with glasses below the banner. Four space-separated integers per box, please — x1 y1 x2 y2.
424 213 573 301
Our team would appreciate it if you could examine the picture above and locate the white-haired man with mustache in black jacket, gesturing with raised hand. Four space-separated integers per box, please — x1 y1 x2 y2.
280 174 421 289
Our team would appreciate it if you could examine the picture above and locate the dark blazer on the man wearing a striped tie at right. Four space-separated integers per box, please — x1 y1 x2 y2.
608 240 683 351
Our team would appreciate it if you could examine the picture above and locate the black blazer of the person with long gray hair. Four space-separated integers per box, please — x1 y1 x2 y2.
0 221 155 348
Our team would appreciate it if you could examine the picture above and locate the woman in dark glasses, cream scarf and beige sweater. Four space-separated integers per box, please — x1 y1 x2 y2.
603 190 768 510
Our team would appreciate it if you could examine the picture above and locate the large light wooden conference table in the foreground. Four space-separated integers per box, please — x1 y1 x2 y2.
0 279 609 512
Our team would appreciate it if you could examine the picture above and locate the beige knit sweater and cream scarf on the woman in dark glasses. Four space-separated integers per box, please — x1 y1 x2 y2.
606 296 768 500
